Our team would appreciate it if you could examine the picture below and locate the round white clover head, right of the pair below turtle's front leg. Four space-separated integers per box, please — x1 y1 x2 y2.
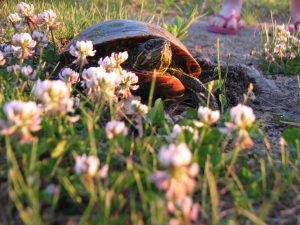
230 104 255 129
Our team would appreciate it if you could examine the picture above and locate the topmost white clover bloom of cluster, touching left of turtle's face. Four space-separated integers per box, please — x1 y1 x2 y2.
98 52 128 72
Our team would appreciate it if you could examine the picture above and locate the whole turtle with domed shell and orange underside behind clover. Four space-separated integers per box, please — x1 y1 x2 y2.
63 19 217 108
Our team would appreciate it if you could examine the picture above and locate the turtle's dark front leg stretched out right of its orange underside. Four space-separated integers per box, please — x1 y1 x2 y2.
168 68 219 109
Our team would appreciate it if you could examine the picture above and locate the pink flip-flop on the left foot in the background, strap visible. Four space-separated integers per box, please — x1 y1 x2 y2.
207 14 243 35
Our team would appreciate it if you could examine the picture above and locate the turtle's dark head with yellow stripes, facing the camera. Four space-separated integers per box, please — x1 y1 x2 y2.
131 38 172 72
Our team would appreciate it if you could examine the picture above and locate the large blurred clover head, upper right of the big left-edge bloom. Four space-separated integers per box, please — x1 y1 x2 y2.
34 80 74 115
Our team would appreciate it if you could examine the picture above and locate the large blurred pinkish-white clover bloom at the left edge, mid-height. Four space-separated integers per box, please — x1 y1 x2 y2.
0 101 41 142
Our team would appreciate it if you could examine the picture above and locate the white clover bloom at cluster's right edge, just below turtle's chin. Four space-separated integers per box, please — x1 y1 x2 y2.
116 70 139 98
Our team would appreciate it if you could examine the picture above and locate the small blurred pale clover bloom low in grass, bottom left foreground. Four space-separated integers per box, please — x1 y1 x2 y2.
74 155 100 177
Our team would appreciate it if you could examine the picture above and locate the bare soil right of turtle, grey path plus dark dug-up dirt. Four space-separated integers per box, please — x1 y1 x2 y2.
184 21 300 149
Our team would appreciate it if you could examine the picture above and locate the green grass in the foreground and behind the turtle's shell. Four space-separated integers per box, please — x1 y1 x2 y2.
0 0 300 225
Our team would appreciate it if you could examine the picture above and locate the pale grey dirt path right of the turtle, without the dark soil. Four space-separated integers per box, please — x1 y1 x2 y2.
184 21 300 149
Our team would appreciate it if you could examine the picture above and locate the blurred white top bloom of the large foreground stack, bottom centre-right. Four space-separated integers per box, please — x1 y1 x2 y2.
158 144 192 168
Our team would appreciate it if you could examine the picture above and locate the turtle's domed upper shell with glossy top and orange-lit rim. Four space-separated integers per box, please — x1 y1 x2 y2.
63 20 201 76
